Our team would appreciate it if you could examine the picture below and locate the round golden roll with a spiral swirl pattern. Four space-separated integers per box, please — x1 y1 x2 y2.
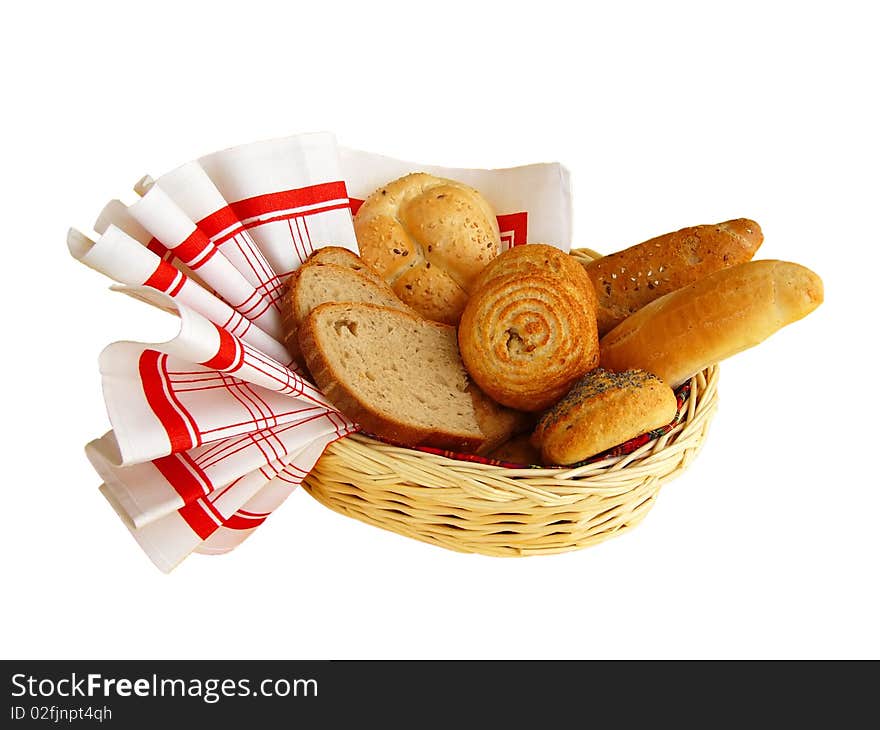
458 243 599 412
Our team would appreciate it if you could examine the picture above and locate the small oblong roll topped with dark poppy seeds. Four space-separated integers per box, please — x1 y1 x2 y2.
532 368 677 464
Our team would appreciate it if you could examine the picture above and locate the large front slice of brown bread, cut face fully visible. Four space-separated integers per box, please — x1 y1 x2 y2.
299 303 520 451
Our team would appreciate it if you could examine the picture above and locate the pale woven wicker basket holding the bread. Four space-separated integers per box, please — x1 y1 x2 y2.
303 249 718 556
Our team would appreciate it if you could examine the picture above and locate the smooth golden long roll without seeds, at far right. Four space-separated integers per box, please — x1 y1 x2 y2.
599 261 823 388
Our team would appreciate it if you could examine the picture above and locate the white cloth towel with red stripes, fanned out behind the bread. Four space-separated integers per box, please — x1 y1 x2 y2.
74 133 571 570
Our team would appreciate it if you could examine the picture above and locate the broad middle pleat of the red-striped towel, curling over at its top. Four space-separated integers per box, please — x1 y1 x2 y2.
98 290 335 466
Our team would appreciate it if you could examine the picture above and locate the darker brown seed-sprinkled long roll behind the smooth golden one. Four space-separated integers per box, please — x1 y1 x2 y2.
581 218 764 337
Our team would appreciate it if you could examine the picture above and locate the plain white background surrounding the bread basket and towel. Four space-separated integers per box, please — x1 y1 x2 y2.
0 0 880 659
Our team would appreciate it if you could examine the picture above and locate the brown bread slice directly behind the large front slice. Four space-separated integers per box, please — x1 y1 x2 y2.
282 255 412 364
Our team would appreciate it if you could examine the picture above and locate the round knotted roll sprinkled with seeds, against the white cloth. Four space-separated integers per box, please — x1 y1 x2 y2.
354 172 501 325
